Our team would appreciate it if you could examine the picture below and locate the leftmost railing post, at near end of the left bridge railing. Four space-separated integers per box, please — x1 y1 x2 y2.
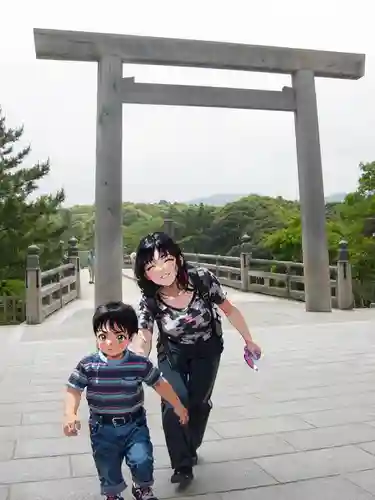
26 245 43 325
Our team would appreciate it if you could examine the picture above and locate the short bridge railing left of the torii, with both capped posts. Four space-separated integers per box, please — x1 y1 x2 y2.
26 238 81 325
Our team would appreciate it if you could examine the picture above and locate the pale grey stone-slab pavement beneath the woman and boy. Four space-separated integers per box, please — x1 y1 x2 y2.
0 276 375 500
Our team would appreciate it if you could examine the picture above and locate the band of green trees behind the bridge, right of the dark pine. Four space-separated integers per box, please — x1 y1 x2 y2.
66 162 375 306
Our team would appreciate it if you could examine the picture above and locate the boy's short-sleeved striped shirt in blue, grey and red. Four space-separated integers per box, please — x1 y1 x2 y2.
67 350 162 415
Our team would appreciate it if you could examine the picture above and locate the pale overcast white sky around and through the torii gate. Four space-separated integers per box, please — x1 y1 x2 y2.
0 0 375 204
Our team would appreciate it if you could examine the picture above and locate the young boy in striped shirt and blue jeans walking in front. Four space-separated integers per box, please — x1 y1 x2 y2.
64 302 188 500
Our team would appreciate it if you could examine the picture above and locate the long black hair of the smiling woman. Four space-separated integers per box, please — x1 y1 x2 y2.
134 232 189 297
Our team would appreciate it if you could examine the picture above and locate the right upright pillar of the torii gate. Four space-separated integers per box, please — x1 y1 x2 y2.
292 70 332 312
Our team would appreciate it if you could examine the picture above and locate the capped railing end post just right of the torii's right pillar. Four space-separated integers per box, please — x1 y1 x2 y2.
336 240 354 309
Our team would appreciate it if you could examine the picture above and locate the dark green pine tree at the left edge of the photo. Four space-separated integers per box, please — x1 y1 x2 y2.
0 109 66 280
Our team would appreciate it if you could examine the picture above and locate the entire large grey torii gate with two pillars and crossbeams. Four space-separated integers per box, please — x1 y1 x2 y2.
34 29 365 312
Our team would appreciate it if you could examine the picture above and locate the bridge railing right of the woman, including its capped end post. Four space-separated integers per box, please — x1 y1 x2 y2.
185 241 353 309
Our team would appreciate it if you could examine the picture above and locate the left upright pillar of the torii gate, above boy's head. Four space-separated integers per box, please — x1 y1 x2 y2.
95 55 123 307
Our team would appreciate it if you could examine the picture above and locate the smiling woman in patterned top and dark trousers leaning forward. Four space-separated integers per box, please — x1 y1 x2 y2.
134 233 260 486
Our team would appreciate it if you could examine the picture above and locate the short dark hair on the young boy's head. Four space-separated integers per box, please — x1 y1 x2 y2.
92 301 138 338
